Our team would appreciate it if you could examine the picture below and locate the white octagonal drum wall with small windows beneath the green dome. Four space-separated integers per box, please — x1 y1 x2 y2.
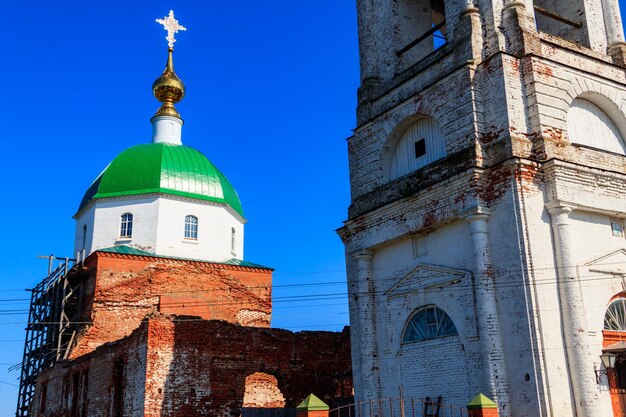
74 195 244 262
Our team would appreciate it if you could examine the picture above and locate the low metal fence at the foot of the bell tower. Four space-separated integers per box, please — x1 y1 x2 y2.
330 397 468 417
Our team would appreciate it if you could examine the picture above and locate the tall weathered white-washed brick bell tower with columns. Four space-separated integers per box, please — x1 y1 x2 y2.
339 0 626 417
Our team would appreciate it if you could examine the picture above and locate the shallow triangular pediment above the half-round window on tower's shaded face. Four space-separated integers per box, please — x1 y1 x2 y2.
385 264 471 297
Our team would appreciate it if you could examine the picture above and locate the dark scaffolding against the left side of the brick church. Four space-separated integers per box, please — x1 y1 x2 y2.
15 255 84 417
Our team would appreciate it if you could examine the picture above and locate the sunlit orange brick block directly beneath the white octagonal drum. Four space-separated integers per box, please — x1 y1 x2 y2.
71 252 272 358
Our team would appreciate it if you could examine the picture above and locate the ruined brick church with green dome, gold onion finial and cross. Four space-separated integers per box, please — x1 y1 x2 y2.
16 12 352 417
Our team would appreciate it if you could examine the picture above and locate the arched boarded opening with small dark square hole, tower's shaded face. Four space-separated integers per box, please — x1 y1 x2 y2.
389 117 446 180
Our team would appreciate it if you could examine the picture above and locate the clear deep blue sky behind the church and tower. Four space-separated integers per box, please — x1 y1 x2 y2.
0 0 626 416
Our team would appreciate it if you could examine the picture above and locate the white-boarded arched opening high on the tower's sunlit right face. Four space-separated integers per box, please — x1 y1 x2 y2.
567 98 626 155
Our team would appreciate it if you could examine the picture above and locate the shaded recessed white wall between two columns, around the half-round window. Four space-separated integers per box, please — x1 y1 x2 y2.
373 221 479 404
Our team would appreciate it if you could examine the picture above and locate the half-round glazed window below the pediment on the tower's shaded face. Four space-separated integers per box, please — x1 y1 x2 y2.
402 306 458 343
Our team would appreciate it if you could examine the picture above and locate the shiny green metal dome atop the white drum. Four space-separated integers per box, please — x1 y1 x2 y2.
78 143 243 217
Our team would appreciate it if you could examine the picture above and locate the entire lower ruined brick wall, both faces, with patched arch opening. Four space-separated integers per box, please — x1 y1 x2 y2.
33 315 352 417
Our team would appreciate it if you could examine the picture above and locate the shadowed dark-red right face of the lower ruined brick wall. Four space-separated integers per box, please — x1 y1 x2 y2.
146 317 352 417
